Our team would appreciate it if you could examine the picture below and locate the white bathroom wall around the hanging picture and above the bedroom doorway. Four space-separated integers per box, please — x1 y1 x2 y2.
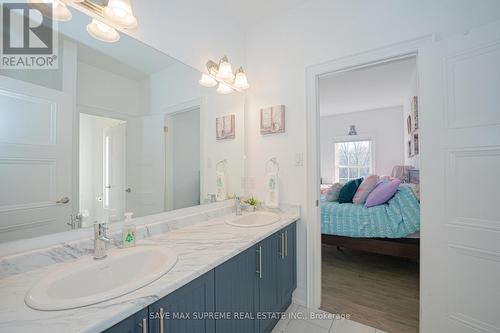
245 0 500 301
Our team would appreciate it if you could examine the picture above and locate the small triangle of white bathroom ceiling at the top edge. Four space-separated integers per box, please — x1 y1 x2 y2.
212 0 309 27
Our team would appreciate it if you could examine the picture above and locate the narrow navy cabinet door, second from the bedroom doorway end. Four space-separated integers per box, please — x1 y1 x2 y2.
257 231 281 332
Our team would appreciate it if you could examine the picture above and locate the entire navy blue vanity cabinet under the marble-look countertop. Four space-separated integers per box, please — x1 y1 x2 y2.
100 223 297 333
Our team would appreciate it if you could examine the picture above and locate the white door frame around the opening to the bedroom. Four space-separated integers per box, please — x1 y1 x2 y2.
305 35 435 318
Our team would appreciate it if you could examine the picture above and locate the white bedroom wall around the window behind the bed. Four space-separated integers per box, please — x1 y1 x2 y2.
320 106 404 182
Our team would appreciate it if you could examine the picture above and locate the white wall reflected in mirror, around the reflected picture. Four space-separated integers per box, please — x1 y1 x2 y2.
151 64 245 200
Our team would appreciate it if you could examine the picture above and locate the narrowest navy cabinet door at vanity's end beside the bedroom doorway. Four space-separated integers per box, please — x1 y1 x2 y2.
280 223 297 310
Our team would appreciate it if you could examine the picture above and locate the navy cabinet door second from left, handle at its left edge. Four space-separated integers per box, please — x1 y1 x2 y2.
149 270 215 333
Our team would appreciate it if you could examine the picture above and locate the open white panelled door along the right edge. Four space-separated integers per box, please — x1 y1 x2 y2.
418 22 500 333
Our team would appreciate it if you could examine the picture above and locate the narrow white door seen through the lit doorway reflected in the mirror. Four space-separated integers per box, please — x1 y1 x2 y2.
103 123 127 221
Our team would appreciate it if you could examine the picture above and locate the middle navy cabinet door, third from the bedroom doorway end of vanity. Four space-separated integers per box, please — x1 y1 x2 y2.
215 246 259 333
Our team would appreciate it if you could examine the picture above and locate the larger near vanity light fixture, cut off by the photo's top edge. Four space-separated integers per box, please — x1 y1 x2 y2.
28 0 137 43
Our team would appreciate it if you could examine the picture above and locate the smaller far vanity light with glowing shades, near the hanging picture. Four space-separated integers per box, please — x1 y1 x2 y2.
198 56 250 94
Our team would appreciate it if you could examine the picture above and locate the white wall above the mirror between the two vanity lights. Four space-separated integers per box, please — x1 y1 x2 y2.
129 0 245 70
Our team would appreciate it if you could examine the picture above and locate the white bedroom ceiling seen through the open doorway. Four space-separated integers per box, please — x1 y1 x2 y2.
319 58 416 116
